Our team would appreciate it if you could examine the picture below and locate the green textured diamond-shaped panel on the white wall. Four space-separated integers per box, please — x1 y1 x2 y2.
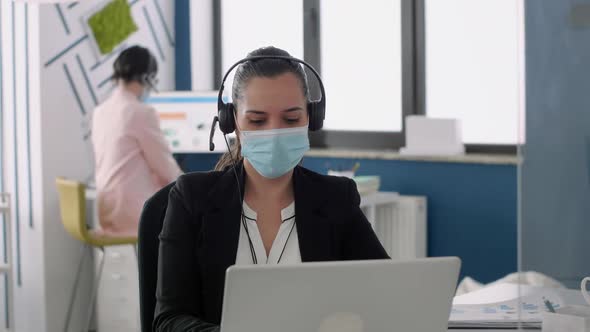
88 0 137 54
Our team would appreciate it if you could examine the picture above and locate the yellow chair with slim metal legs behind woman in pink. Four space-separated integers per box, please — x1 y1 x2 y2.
55 178 137 332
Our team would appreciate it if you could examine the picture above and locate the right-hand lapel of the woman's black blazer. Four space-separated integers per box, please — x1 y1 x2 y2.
293 166 335 262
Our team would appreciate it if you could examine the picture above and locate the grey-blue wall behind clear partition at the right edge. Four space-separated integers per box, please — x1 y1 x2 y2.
522 0 590 288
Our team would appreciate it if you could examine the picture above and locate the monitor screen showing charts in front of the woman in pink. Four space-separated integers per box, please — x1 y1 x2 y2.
146 91 233 153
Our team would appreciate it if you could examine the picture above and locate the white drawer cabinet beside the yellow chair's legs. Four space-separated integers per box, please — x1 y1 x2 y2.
96 246 140 332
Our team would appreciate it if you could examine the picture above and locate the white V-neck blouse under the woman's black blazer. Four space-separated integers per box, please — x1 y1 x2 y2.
236 202 301 265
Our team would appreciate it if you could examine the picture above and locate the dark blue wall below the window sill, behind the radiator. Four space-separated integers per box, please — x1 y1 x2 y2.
176 154 517 282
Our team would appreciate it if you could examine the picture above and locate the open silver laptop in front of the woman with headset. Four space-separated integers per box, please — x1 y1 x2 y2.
221 257 461 332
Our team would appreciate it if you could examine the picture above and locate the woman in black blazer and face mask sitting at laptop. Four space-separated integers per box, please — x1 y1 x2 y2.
154 47 388 331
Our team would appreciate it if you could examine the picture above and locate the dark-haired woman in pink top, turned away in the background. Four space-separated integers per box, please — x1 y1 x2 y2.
92 46 182 236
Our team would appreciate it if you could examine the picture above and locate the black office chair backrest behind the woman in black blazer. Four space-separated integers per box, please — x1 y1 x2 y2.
137 182 176 332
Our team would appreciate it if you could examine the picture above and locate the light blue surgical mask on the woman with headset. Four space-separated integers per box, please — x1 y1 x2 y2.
240 126 309 179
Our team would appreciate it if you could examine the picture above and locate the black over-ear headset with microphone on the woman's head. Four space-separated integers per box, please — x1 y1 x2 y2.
211 55 326 135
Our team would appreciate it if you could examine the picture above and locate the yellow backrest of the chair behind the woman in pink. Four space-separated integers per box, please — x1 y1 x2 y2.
55 178 88 242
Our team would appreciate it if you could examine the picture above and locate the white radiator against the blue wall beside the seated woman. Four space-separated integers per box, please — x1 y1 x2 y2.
361 192 427 259
